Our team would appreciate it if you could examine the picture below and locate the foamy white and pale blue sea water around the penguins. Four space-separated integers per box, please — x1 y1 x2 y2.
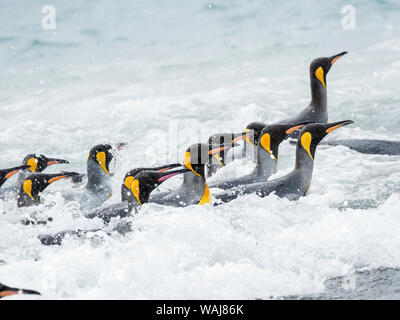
0 0 400 299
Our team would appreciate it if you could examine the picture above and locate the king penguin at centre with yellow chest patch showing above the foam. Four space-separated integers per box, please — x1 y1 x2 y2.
149 143 236 207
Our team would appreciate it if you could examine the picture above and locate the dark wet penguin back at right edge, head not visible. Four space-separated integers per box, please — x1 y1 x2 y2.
324 139 400 156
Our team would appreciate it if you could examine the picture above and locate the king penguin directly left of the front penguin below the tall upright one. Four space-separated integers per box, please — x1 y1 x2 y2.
210 121 309 189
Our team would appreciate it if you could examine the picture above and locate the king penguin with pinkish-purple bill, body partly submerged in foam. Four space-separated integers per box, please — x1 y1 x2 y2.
38 168 190 246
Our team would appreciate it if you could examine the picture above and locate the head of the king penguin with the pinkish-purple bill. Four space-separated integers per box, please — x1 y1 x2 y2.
128 168 191 212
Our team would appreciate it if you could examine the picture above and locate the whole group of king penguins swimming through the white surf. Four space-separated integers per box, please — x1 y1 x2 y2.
0 52 400 298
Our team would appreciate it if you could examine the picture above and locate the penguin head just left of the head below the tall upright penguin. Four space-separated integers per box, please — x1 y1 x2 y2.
259 120 311 160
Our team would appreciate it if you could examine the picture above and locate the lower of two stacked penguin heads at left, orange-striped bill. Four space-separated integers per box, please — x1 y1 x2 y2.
18 172 79 207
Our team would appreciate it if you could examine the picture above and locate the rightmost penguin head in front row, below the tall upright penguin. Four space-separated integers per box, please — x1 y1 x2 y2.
298 120 353 160
